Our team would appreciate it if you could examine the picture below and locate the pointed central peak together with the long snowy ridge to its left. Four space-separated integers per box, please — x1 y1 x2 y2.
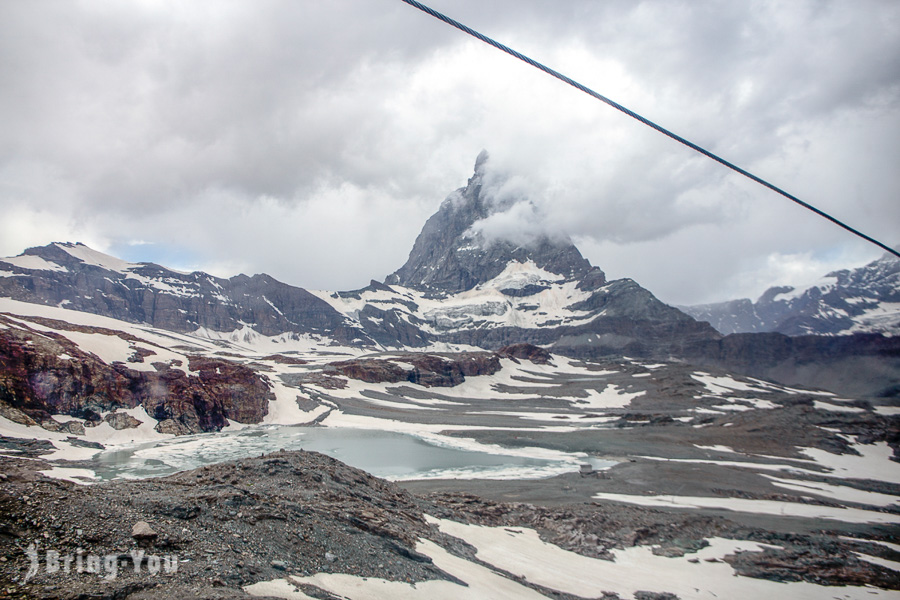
0 153 721 357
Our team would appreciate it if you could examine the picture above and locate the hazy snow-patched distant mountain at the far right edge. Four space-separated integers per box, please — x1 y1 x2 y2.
681 253 900 336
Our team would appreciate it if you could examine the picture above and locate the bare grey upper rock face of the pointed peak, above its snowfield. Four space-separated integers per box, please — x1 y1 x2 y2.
386 152 605 293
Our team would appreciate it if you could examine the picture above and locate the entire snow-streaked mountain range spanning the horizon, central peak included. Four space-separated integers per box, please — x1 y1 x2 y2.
0 152 900 393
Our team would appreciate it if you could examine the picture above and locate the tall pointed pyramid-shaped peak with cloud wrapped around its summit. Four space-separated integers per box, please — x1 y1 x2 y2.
321 152 720 356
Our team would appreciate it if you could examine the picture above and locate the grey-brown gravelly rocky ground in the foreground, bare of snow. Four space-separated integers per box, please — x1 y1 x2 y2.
0 443 900 600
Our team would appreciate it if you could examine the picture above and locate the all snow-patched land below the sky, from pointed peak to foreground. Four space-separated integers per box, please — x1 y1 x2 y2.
0 155 900 600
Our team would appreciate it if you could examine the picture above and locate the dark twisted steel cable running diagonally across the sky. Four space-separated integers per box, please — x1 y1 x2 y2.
402 0 900 258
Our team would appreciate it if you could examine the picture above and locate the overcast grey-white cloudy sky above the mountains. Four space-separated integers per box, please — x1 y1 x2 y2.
0 0 900 304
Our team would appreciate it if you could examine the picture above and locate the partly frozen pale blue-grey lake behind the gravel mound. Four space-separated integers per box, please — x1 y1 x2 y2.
91 425 614 480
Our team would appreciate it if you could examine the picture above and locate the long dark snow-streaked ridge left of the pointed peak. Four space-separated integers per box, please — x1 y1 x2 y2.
0 243 371 343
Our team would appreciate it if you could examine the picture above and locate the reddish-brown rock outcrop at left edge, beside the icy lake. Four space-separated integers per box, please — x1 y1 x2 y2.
0 315 274 434
